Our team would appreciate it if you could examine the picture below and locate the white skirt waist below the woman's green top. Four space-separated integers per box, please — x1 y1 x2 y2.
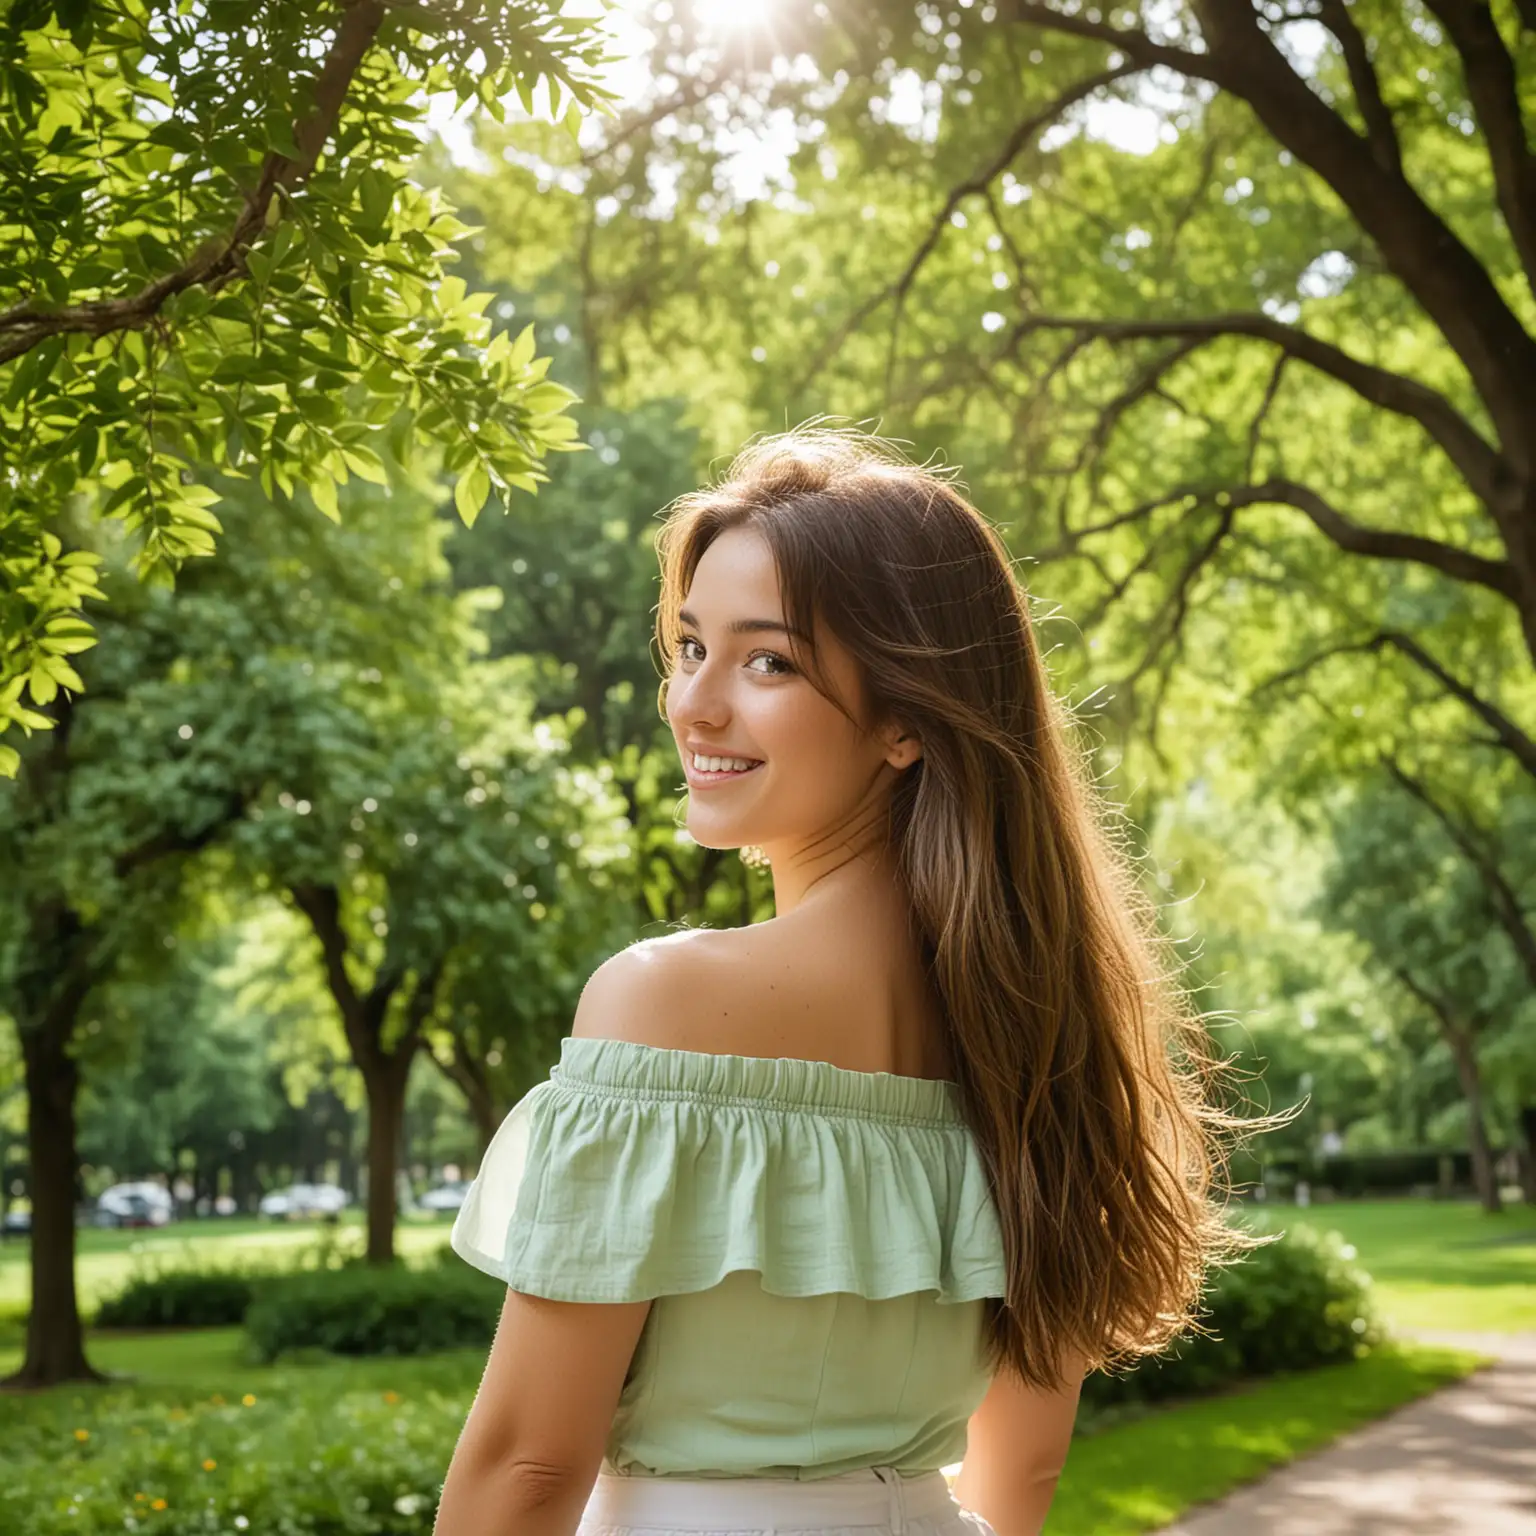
576 1467 997 1536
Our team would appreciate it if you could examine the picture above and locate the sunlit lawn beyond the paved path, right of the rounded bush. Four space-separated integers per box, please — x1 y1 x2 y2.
1247 1200 1536 1333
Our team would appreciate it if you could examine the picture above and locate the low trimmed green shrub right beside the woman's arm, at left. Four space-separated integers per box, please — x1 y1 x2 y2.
246 1264 505 1361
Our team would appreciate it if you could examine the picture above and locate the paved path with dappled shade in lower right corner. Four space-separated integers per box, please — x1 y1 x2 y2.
1164 1332 1536 1536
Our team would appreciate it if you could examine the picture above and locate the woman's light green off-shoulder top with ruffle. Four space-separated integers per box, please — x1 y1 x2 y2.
450 1037 1005 1479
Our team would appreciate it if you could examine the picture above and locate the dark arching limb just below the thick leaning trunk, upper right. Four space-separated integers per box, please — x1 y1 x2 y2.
1008 312 1510 505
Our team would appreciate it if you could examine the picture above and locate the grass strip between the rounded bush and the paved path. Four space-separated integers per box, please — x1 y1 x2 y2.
1046 1346 1481 1536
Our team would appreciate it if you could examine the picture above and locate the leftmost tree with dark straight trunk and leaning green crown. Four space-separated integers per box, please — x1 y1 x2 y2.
0 457 454 1385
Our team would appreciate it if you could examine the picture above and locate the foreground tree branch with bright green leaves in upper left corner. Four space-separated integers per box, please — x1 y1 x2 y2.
0 0 607 774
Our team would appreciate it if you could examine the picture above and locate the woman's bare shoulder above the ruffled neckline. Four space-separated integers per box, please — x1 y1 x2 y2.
571 925 790 1055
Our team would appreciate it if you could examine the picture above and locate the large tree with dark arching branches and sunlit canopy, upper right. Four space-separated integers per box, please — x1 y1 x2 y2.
457 0 1536 780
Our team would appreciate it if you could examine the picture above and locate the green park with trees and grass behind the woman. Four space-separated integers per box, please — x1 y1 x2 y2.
0 0 1536 1536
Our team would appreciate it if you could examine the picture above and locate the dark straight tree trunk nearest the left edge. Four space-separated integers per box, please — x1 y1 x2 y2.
0 1018 111 1392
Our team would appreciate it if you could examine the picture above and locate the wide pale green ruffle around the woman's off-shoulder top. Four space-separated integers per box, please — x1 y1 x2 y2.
450 1037 1006 1303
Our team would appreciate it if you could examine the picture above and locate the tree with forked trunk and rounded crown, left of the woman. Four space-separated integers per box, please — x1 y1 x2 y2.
208 457 627 1264
